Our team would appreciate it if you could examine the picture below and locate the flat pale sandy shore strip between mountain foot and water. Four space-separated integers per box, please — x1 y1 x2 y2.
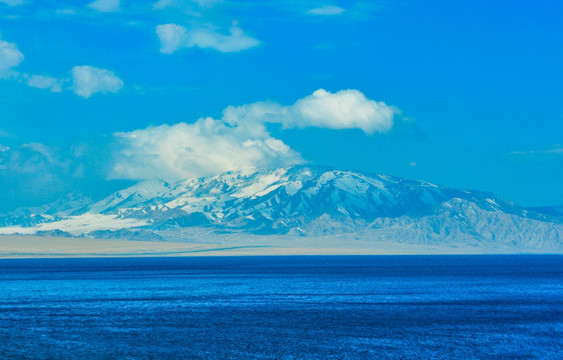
0 235 556 259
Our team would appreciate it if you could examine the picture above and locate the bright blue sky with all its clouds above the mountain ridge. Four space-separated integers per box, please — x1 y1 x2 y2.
0 0 563 211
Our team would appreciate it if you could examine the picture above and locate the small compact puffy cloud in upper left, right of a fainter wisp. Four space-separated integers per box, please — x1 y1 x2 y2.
72 65 123 98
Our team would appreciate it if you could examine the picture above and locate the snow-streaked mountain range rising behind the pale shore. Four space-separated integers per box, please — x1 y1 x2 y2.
0 165 563 252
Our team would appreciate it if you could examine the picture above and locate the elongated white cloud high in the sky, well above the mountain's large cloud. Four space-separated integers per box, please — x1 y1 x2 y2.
156 22 260 54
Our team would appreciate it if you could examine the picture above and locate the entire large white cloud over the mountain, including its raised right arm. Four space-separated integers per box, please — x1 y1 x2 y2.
110 89 397 180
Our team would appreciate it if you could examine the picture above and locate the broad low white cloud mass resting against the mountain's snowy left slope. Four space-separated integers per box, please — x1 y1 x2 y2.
110 118 302 180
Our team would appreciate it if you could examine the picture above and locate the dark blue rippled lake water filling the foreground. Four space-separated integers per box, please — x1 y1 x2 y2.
0 256 563 359
